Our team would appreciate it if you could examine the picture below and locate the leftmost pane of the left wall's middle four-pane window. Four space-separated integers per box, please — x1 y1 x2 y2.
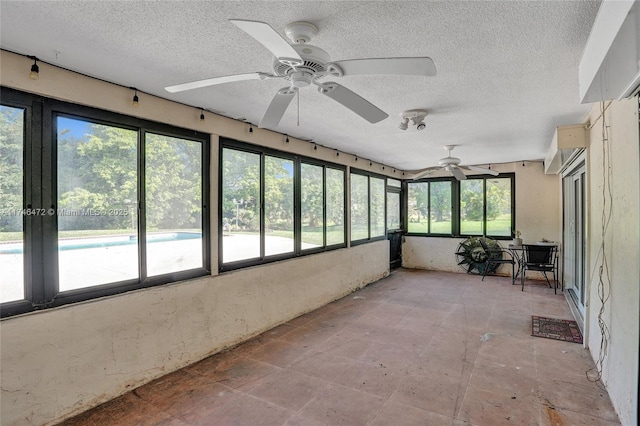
222 148 260 262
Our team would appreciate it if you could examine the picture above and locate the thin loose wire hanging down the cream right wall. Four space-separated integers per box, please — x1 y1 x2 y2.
586 102 613 389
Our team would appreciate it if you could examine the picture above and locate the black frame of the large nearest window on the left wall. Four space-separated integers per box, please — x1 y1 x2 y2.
0 86 211 318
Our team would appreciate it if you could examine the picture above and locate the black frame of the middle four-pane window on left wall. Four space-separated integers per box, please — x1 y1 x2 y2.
218 137 348 273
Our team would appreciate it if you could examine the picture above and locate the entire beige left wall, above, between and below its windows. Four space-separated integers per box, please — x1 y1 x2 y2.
0 51 394 425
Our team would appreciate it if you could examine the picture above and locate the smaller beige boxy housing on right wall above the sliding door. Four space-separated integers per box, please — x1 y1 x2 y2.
544 124 589 175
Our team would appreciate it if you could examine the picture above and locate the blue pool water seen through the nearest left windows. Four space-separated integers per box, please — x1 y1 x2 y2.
0 232 202 254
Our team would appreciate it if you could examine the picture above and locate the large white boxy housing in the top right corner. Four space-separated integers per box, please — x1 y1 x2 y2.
578 0 640 104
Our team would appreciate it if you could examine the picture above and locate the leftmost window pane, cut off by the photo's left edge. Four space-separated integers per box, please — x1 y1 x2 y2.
0 106 28 302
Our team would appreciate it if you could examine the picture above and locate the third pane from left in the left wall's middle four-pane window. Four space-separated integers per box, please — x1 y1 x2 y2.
300 163 324 250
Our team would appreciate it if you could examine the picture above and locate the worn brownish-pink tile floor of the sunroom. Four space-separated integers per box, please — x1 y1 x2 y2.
58 269 619 426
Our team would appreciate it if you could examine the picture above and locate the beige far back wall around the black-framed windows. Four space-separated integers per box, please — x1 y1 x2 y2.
402 162 562 278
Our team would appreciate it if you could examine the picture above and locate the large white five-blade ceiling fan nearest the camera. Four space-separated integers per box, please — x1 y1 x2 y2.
165 19 436 127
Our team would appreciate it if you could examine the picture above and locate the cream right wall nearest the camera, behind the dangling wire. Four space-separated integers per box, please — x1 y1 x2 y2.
585 97 640 426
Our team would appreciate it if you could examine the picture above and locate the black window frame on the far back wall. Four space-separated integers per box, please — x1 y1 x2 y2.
402 172 516 240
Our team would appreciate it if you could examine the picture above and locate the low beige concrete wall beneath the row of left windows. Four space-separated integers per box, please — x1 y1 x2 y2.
0 241 389 425
